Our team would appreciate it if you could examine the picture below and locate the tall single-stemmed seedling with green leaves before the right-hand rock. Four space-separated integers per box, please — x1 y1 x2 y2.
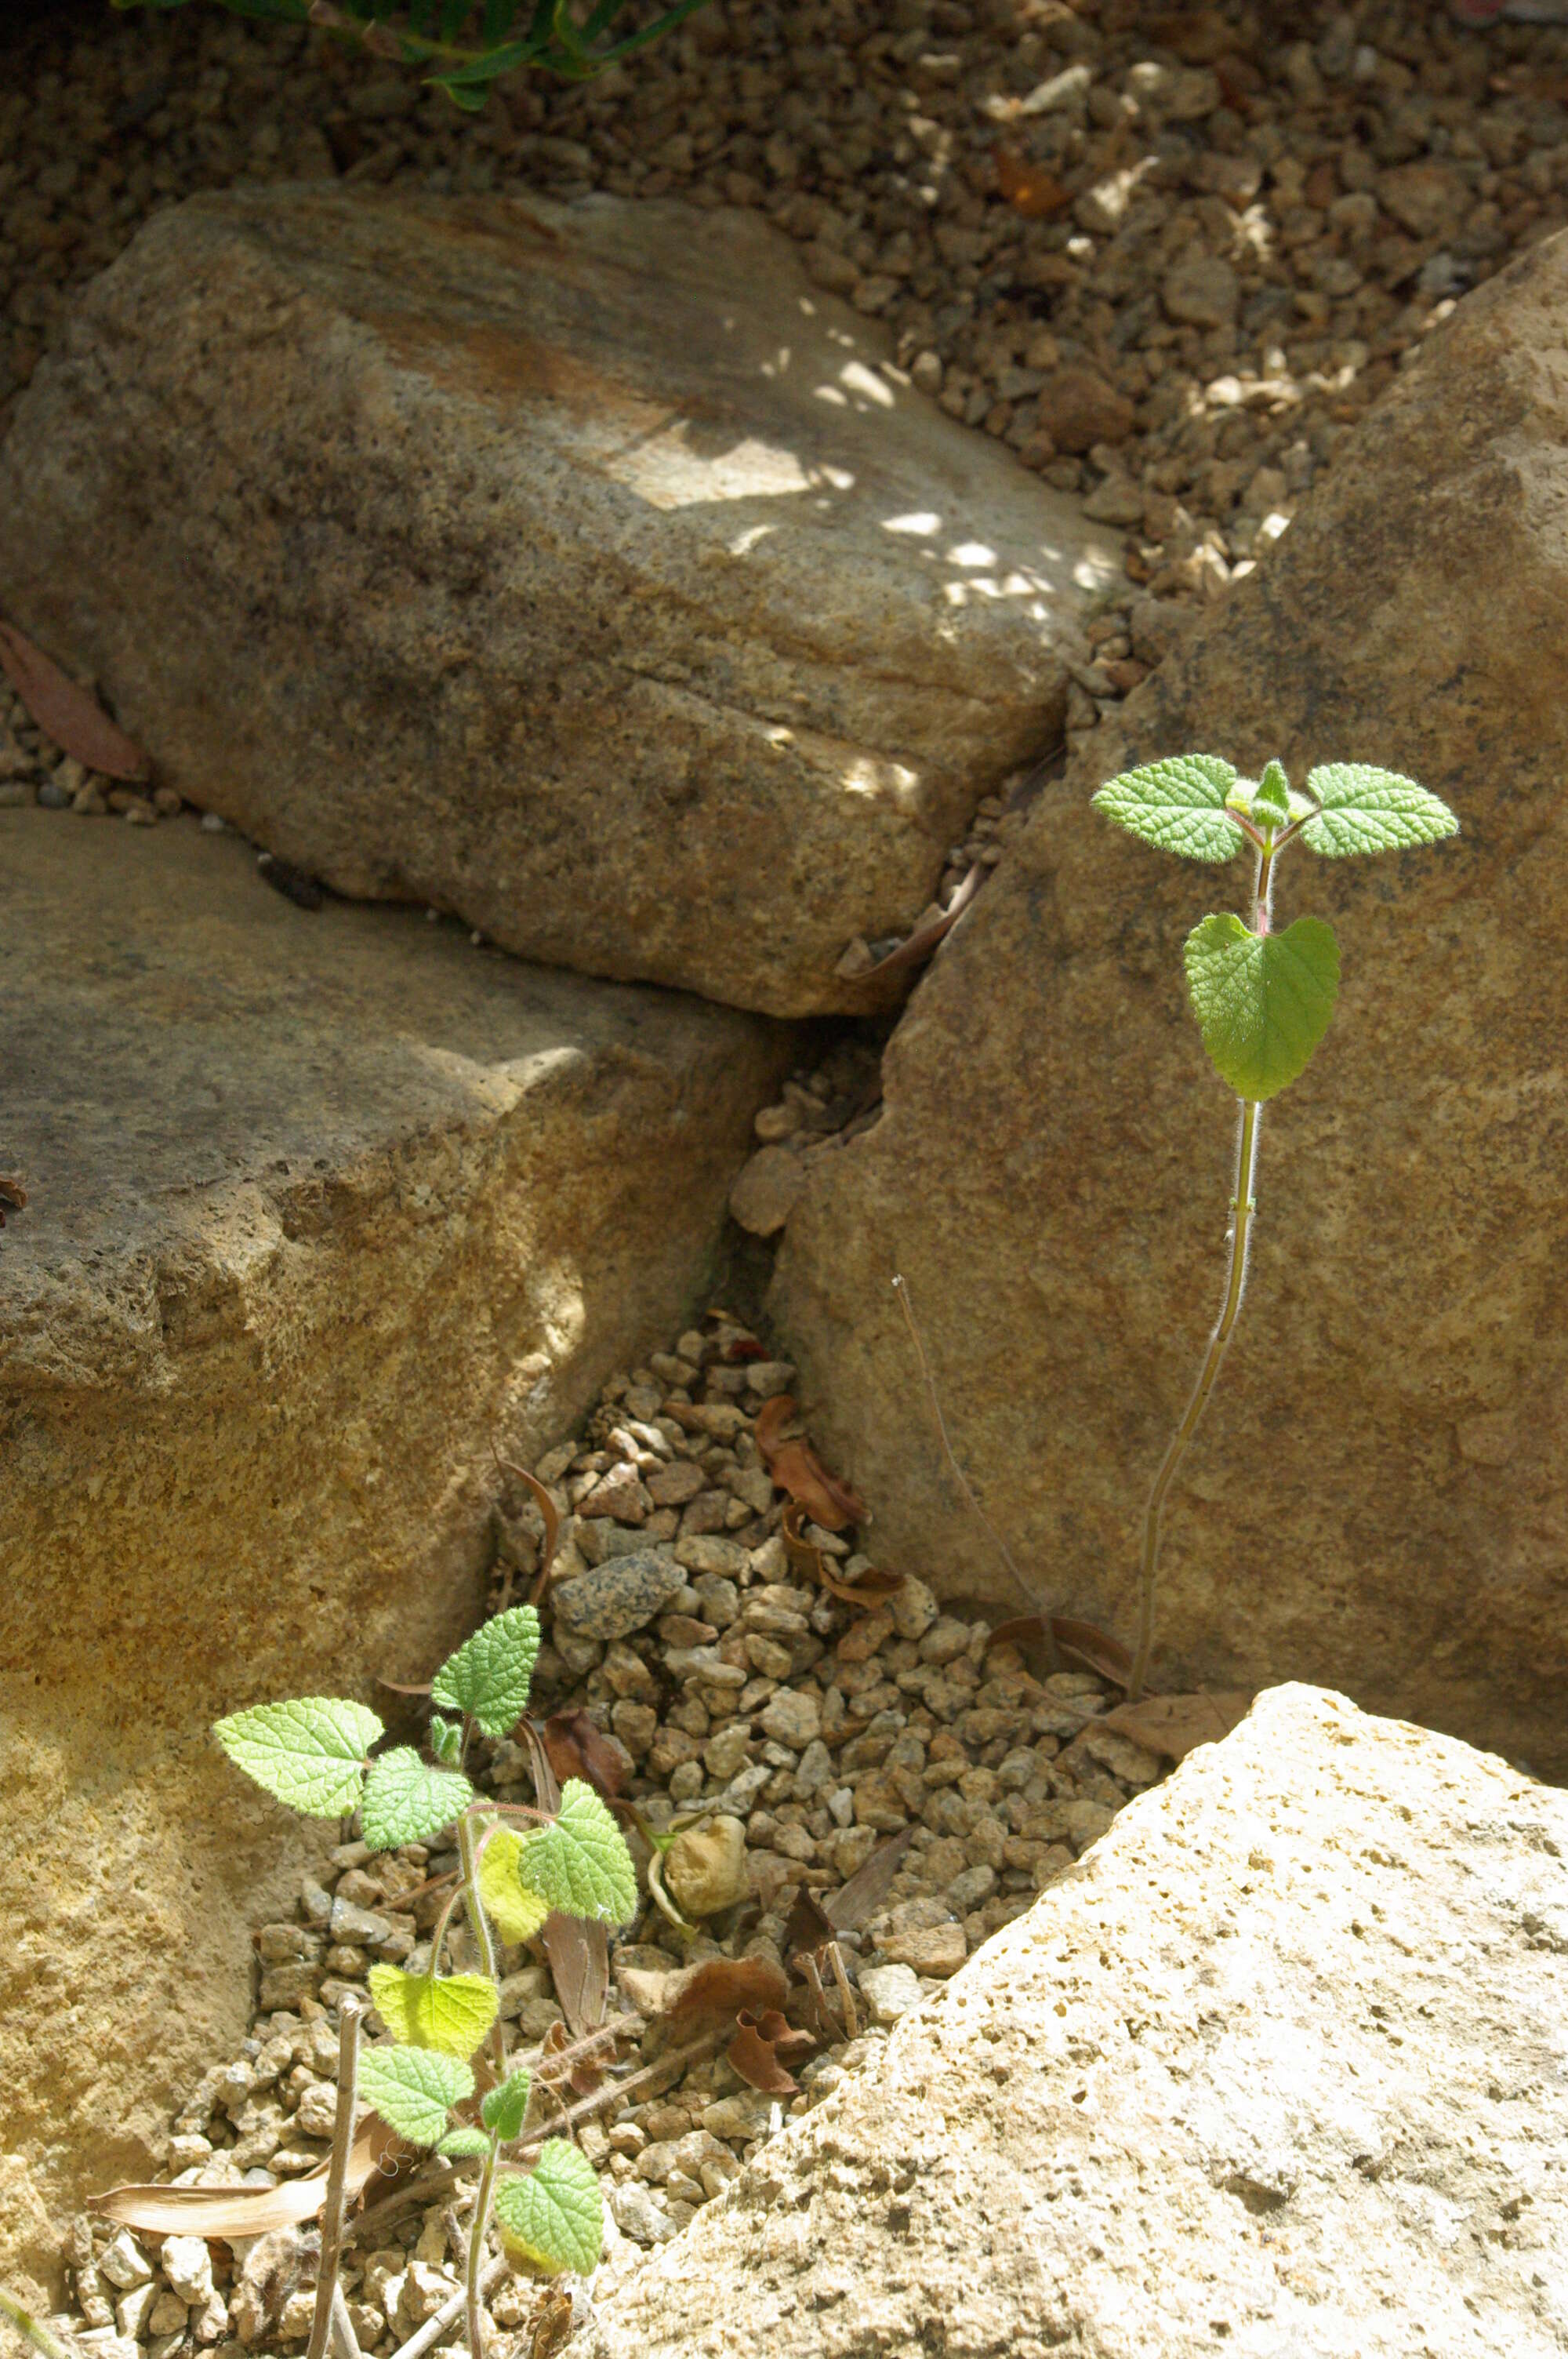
1094 753 1460 1701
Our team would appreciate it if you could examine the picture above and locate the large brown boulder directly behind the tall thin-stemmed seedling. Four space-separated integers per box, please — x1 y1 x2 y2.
775 238 1568 1772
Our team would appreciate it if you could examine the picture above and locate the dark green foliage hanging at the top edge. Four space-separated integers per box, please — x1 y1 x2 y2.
113 0 702 113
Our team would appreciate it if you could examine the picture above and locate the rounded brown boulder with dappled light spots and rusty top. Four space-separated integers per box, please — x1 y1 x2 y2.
0 187 1118 1014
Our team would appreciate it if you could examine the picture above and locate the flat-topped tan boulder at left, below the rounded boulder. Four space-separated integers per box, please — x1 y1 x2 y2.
0 812 780 2277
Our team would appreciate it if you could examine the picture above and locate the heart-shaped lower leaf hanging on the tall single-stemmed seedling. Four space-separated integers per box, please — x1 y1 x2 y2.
1184 913 1339 1102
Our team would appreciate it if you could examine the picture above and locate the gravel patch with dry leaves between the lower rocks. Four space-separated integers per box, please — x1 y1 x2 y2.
49 1311 1163 2359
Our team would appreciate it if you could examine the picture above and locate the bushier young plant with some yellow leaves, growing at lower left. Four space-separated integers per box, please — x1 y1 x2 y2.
215 1606 637 2359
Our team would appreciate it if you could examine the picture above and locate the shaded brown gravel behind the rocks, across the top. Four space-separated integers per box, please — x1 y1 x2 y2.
0 0 1568 811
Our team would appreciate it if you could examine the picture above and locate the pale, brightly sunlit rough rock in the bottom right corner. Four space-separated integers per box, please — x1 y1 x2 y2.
593 1687 1568 2359
